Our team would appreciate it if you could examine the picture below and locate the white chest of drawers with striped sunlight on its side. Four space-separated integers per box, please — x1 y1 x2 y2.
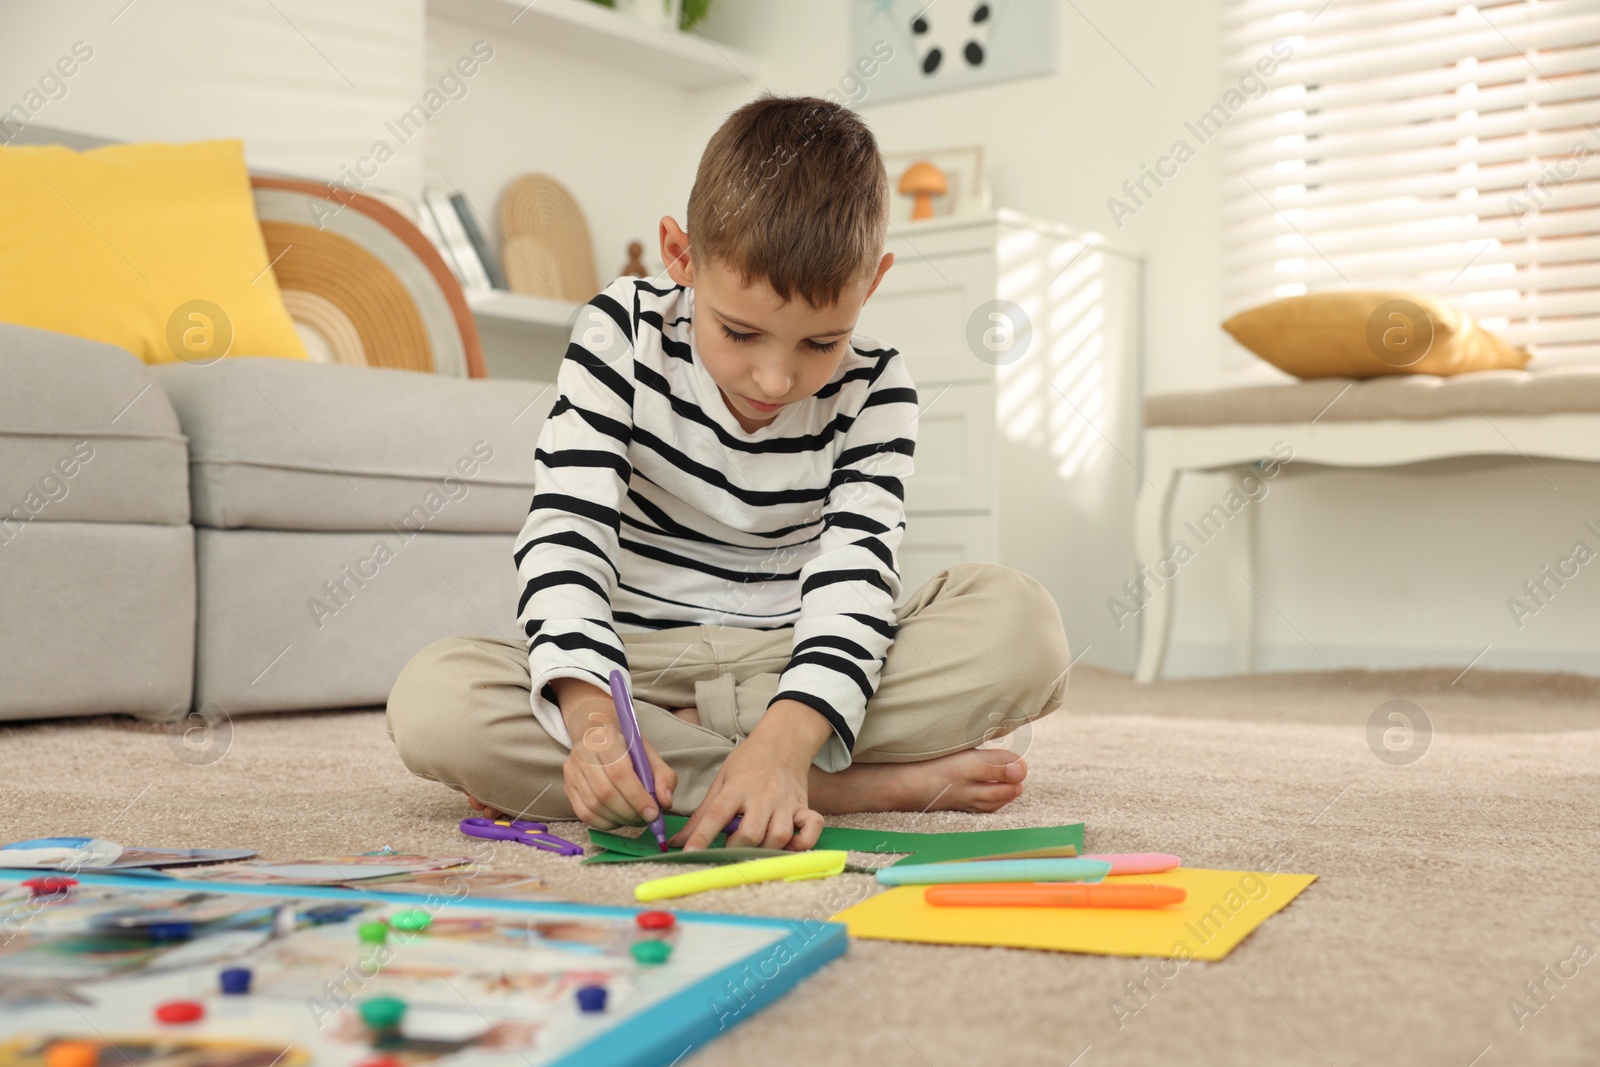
858 210 1142 670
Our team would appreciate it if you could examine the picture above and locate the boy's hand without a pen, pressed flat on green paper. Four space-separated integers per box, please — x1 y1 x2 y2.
667 701 832 851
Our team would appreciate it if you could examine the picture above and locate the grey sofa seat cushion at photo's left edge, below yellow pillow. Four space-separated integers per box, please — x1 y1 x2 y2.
0 325 189 531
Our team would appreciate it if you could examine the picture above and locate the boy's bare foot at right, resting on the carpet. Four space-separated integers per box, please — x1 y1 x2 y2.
808 749 1027 814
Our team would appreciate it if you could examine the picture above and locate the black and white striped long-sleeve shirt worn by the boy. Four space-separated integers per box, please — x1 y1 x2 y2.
515 277 917 771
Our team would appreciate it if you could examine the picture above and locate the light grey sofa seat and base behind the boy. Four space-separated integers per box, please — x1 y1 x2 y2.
0 325 555 721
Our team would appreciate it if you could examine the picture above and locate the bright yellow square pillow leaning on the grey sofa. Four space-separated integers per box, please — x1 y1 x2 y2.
0 141 306 363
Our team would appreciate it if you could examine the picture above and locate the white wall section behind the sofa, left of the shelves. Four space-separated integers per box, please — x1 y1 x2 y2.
0 0 422 192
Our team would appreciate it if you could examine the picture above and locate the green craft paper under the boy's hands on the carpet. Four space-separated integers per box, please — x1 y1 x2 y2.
584 816 1083 865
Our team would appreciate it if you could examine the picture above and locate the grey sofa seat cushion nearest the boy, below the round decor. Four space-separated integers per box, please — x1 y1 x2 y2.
152 358 555 533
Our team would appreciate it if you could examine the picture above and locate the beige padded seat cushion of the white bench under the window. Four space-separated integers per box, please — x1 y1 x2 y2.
1144 366 1600 427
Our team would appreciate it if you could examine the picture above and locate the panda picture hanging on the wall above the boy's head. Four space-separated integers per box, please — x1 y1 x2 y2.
850 0 1058 107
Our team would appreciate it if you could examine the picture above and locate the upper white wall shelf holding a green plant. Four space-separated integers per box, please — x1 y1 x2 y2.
427 0 757 88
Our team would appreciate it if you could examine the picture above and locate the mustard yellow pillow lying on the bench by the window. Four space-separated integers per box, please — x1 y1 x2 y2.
1222 290 1528 378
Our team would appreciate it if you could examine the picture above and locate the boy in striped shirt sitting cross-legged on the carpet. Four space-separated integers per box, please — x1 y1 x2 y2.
389 94 1069 849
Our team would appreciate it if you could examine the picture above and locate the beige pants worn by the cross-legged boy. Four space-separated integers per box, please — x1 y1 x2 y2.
389 563 1070 819
